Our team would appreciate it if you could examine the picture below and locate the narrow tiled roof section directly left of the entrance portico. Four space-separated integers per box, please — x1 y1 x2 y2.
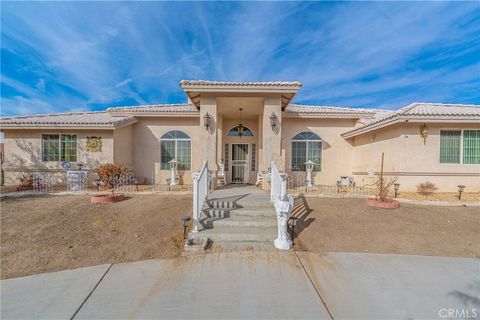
107 103 200 117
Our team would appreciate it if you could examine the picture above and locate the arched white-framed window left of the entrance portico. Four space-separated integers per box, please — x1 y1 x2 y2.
160 130 192 170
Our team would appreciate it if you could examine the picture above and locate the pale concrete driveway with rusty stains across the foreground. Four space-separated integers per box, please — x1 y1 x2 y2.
1 251 480 319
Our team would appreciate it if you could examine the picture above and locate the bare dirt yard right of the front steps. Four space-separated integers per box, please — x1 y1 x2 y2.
294 197 480 258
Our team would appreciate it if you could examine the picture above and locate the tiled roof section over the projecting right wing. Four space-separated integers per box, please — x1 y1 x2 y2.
342 102 480 138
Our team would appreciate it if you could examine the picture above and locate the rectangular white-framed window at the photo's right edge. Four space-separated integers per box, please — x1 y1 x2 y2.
440 130 480 164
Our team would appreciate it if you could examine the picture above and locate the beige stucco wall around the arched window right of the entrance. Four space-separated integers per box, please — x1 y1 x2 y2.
282 117 354 185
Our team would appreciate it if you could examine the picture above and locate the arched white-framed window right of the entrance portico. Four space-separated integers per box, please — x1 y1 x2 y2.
292 131 322 171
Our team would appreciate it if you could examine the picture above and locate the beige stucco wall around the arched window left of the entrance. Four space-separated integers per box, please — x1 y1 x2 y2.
133 117 200 184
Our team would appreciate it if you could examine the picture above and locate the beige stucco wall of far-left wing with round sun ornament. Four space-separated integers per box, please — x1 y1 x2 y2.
3 129 113 184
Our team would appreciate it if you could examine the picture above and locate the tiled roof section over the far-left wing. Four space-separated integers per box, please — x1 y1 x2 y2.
0 111 137 129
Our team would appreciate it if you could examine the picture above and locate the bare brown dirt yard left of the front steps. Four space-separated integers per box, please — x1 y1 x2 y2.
0 195 192 279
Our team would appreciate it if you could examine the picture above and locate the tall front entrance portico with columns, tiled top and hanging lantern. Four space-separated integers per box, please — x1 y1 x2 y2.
180 81 301 189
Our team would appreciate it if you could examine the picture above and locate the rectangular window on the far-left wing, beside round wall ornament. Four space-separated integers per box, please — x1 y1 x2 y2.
42 134 77 162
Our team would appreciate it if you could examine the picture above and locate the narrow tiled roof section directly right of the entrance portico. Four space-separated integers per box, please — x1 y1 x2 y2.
283 104 377 119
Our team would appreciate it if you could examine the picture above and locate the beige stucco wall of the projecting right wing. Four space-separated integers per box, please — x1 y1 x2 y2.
349 123 480 191
